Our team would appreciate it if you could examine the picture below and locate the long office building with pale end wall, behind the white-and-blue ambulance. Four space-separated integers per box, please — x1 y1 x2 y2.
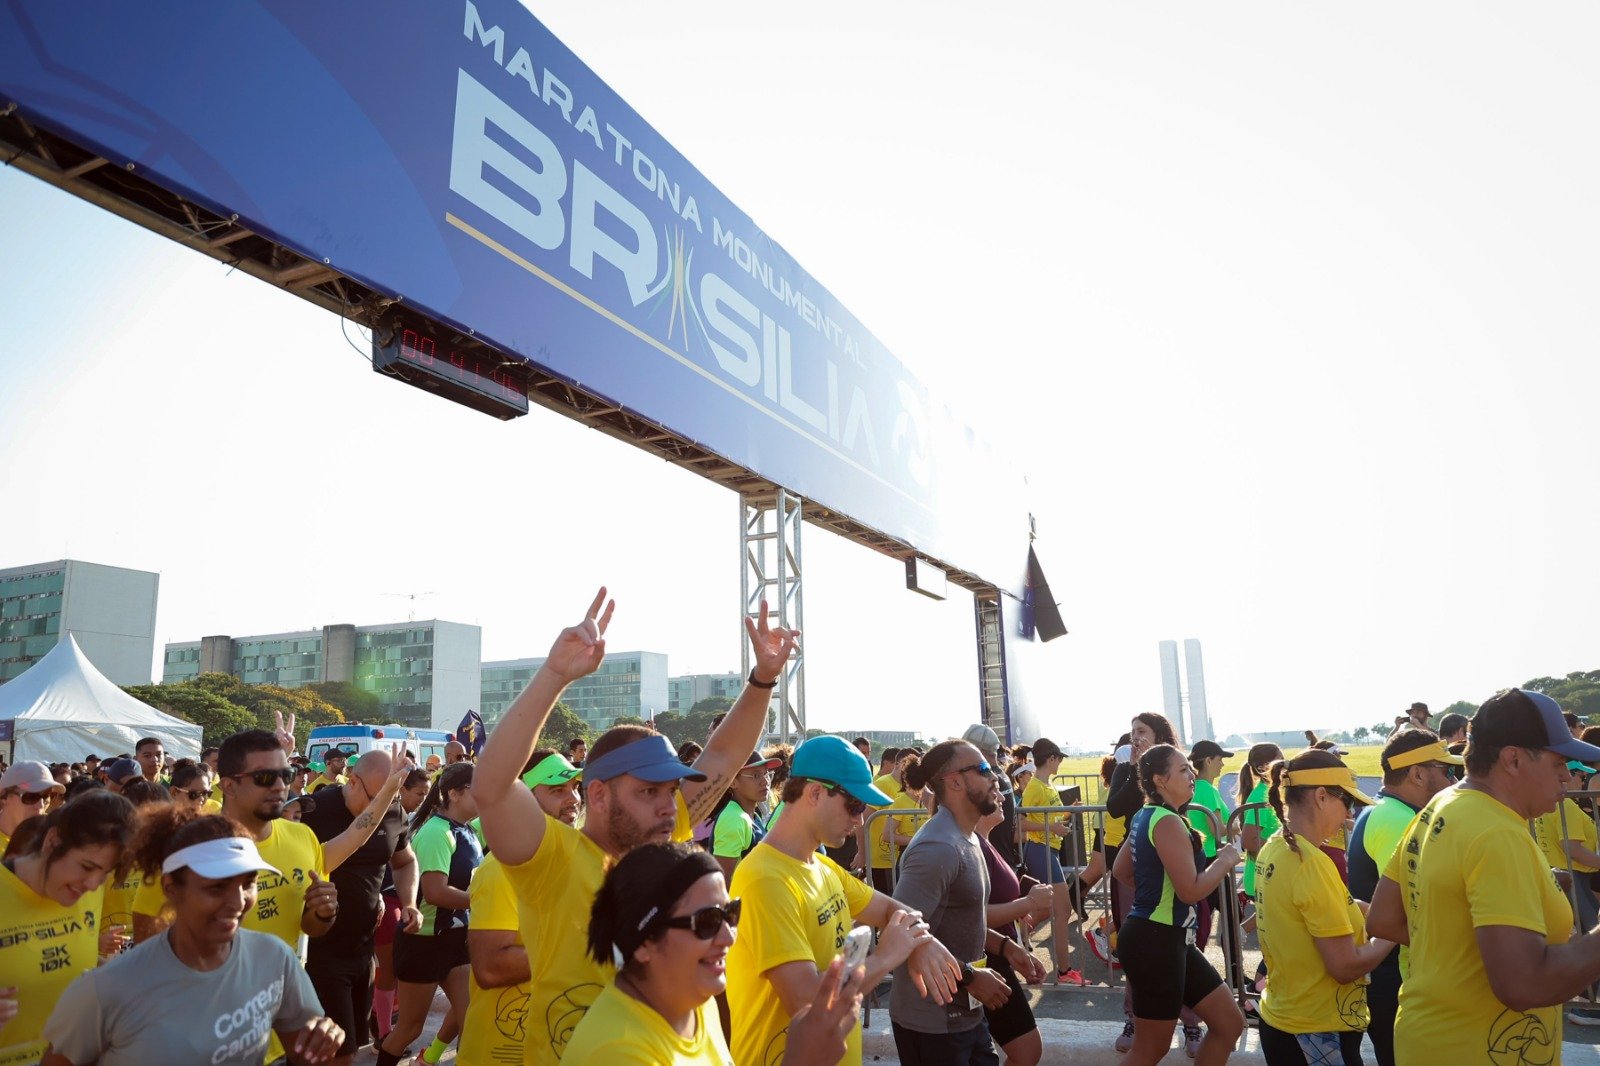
162 618 483 730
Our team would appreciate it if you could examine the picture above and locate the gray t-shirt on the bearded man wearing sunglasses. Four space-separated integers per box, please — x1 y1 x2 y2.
890 807 989 1032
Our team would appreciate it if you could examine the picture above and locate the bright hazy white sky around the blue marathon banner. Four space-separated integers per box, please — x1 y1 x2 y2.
0 2 1600 744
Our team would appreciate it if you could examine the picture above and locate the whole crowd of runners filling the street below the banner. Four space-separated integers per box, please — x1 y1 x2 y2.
0 589 1600 1066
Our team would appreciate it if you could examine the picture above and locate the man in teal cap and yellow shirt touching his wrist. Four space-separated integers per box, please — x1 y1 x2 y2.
729 736 970 1066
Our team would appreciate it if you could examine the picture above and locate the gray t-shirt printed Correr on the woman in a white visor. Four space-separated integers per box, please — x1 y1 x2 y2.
45 928 323 1066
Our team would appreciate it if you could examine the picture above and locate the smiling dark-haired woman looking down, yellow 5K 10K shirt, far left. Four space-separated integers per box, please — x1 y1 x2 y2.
0 791 133 1066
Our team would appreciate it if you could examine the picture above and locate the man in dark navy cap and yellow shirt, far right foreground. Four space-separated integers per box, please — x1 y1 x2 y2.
1366 688 1600 1066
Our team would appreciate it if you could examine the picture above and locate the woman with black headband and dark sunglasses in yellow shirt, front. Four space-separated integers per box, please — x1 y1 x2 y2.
562 844 862 1066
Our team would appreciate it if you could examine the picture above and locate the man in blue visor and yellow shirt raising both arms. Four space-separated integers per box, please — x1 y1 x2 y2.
472 589 798 1066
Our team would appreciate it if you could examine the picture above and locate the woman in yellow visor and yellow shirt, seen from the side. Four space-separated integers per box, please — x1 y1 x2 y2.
1256 749 1394 1066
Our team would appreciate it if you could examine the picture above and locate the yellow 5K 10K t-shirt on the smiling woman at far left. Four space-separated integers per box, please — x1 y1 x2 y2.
0 866 102 1066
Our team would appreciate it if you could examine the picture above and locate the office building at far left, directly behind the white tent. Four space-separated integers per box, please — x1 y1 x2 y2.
0 559 160 685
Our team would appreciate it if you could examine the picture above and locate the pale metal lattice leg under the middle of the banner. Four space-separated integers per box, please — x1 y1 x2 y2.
739 490 805 744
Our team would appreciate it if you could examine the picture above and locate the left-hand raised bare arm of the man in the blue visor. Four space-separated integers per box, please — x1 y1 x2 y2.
472 587 611 866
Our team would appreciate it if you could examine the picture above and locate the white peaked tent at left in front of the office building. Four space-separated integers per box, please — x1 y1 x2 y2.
0 634 202 762
